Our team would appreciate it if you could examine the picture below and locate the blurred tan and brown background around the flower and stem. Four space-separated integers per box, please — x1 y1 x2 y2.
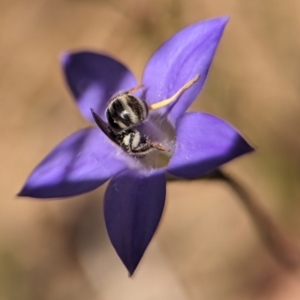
0 0 300 300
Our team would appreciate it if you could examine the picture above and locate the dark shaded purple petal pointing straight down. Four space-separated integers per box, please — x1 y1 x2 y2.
104 170 166 275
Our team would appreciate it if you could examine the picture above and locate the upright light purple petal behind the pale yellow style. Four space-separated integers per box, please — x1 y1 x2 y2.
143 17 228 123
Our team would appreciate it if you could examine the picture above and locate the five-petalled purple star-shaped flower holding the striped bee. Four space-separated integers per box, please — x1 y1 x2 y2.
19 18 253 274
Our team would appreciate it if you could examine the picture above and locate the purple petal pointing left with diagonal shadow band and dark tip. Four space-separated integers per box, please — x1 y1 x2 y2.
19 128 127 198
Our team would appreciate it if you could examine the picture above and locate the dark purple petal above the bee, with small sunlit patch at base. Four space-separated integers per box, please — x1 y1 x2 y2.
62 52 137 121
